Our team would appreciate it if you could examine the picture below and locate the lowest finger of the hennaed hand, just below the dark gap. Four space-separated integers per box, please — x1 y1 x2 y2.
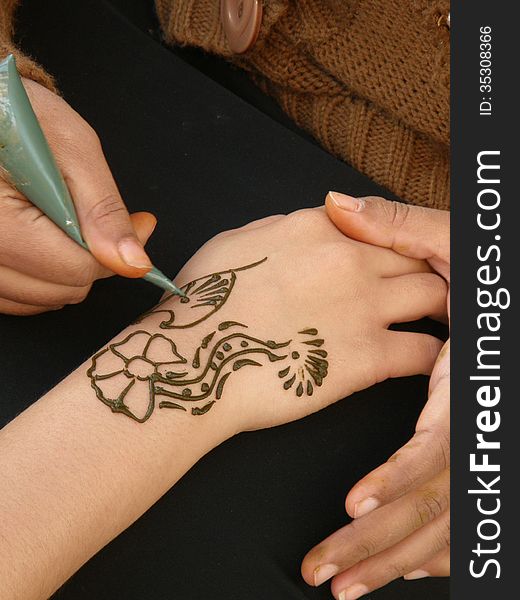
381 330 442 378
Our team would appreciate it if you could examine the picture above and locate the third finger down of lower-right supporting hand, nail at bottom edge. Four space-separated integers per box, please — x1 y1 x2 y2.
332 510 450 600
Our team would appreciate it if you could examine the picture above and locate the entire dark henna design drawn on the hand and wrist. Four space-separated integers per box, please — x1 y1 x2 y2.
87 258 328 423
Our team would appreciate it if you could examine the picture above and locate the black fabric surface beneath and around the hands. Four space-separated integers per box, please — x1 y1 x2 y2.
0 0 448 600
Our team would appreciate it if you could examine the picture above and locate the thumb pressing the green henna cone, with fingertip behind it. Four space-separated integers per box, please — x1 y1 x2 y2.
62 140 155 277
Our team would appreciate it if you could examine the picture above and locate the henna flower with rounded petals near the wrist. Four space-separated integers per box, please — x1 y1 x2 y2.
87 331 186 423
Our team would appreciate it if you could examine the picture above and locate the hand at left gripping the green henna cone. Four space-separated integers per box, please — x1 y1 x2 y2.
0 80 155 315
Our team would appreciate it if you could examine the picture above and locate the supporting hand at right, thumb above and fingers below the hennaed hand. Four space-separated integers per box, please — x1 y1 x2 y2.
302 193 450 600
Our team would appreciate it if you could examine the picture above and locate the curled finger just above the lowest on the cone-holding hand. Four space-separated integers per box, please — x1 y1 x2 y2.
0 266 92 307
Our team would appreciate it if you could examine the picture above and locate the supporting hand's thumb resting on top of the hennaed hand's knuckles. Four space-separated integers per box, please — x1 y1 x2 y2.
325 192 450 281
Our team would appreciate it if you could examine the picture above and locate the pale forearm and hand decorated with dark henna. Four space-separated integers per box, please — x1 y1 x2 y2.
0 209 446 600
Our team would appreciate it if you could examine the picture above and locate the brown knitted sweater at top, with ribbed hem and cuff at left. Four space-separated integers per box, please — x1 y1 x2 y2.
0 0 450 208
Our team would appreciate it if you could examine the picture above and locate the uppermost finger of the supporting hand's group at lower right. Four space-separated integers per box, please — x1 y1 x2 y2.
345 364 450 518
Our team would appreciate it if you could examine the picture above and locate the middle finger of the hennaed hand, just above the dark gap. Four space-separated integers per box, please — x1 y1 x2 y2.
379 273 448 326
